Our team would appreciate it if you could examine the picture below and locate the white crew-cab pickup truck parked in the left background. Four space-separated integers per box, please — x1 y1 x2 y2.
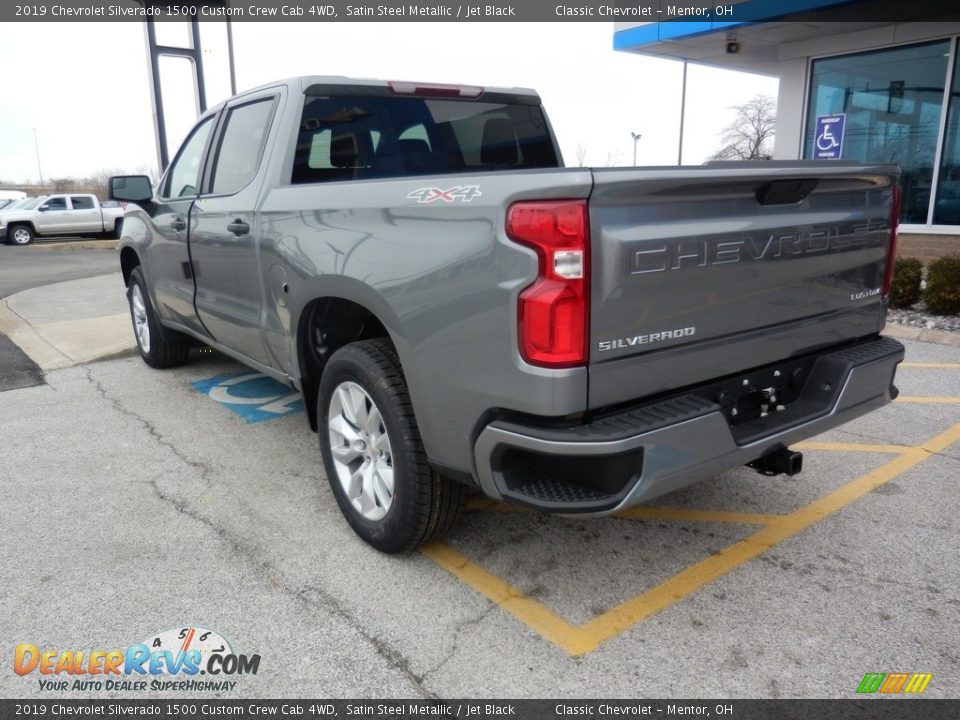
0 193 124 245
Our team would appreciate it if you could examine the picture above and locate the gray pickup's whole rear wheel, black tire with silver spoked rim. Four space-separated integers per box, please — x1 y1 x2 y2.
317 340 467 553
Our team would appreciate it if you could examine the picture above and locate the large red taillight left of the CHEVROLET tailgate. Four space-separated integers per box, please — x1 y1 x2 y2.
507 200 590 368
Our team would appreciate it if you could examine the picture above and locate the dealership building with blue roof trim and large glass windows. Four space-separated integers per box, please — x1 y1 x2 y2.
614 0 960 260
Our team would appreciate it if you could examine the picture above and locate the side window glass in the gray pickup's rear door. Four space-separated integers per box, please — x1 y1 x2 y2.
211 98 273 195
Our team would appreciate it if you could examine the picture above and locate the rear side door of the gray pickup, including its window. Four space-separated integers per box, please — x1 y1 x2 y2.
190 89 281 364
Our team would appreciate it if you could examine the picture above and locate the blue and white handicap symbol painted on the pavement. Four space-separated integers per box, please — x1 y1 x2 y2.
191 372 304 423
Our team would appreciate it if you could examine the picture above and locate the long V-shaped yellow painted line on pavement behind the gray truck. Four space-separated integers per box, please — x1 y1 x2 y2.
423 423 960 655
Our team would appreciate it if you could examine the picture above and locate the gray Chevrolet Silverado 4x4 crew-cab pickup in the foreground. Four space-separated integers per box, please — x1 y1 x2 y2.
111 77 903 552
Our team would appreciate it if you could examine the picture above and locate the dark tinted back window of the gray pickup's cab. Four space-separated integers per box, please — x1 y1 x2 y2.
292 95 558 183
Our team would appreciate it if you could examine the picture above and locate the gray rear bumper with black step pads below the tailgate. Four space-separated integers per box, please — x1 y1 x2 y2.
474 337 904 514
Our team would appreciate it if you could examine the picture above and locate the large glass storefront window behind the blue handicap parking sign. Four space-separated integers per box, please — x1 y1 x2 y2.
804 40 960 224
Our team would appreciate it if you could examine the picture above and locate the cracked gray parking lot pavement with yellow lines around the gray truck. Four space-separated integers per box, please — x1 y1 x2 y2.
0 342 960 698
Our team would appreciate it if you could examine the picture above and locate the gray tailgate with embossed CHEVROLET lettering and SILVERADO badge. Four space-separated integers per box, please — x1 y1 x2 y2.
589 162 898 408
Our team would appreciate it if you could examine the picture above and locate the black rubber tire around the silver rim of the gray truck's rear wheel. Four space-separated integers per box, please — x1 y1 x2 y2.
317 340 467 553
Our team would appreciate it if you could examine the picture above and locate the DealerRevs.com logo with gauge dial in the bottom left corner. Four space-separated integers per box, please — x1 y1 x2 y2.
13 626 260 692
